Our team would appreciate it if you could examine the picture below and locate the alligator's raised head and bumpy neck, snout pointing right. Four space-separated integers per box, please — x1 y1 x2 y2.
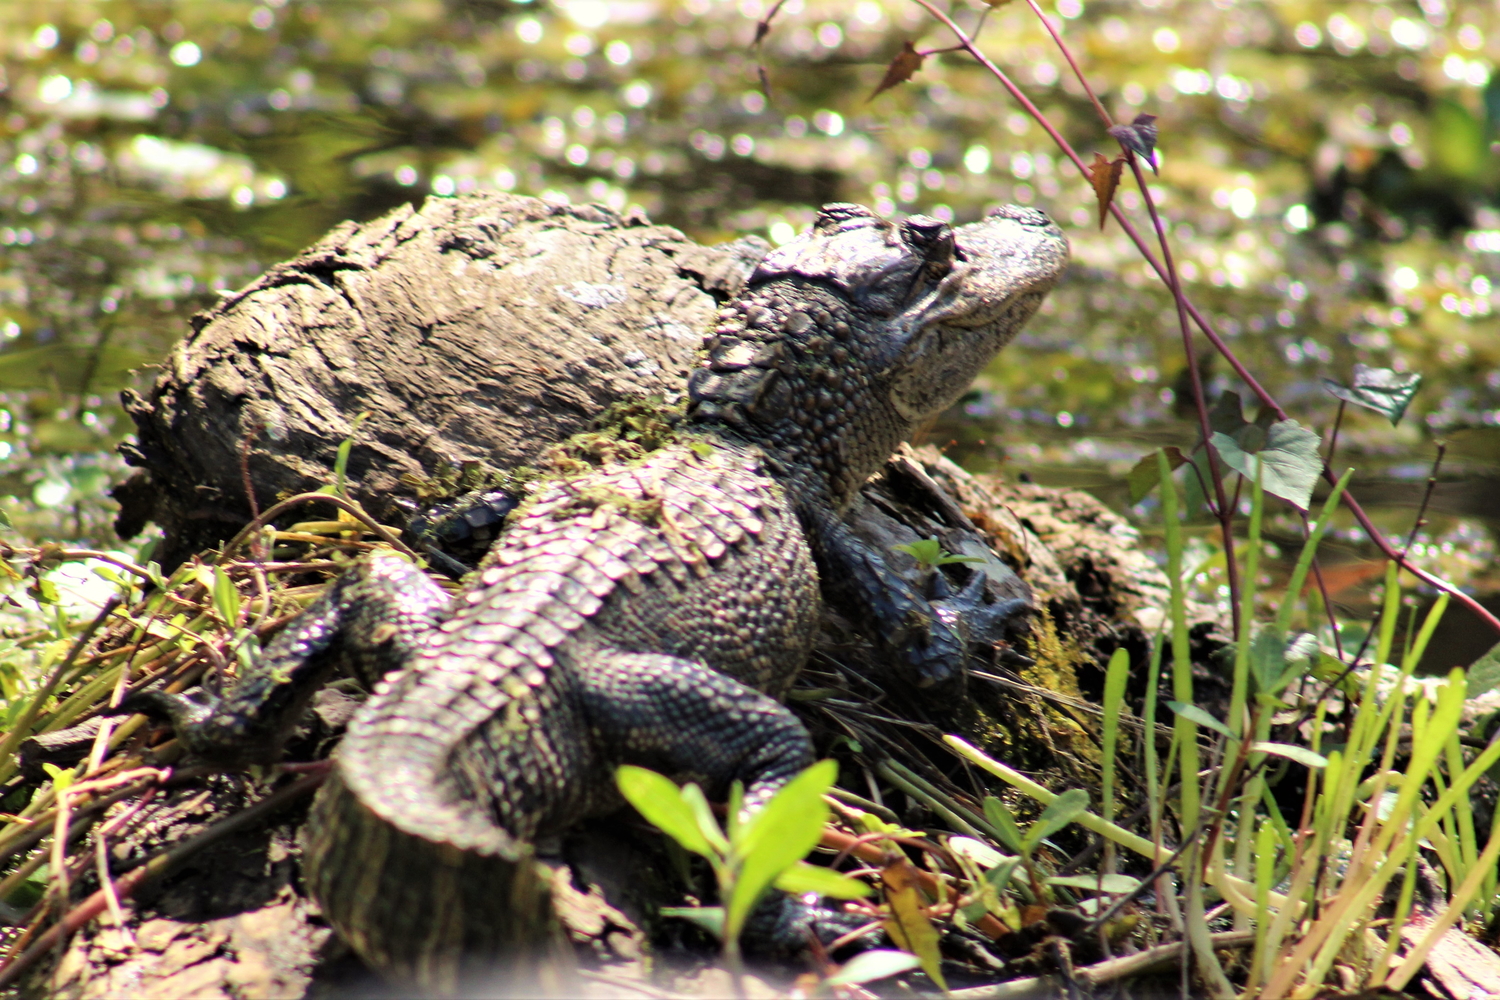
689 204 1068 505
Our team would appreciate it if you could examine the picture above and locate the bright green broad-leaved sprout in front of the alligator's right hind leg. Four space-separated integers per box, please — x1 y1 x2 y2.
615 760 870 975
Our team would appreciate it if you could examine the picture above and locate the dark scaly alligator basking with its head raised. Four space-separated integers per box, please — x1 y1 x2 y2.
126 204 1067 990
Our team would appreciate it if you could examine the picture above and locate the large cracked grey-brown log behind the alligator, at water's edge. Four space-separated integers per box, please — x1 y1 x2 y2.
116 195 768 565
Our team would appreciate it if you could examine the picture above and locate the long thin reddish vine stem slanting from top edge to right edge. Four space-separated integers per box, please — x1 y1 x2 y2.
912 0 1500 634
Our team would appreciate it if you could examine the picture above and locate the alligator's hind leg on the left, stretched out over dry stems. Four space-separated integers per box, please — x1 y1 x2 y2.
119 550 453 766
